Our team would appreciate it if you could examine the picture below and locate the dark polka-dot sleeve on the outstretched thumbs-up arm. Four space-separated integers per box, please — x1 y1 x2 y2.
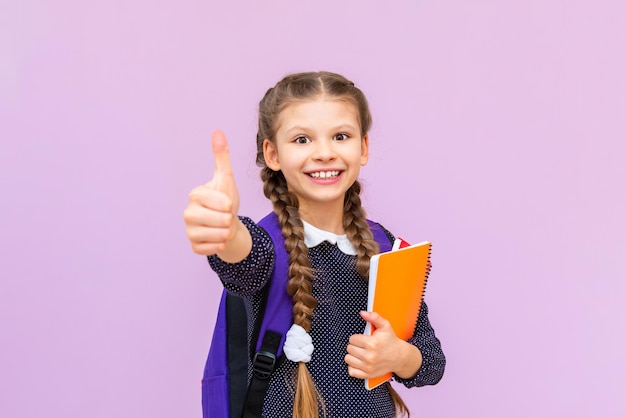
208 216 274 297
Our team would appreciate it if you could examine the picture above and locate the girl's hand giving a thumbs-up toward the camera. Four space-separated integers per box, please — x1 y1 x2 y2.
184 131 245 255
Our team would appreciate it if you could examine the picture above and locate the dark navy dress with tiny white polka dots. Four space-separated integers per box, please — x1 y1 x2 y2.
209 218 445 418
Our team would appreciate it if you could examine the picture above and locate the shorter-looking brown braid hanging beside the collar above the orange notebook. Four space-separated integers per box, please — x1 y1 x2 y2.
343 180 380 277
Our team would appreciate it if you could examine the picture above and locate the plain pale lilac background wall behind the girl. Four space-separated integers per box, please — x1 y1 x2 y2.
0 0 626 418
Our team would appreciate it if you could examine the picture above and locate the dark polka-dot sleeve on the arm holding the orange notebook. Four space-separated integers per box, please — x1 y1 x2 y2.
394 302 446 388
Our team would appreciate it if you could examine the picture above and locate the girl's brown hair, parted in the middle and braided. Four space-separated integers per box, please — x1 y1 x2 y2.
256 72 409 418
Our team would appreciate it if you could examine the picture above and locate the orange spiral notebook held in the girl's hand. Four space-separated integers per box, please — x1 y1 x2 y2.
364 238 431 390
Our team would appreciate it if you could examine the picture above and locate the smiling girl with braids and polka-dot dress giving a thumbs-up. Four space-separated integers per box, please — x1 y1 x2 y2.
184 72 445 418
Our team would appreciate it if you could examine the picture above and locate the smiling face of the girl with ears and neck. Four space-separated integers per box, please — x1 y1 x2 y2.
263 97 369 220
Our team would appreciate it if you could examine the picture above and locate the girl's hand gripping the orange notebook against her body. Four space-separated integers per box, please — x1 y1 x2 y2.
345 312 422 379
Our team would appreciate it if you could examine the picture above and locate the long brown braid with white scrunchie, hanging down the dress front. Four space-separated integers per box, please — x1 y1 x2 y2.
261 167 326 418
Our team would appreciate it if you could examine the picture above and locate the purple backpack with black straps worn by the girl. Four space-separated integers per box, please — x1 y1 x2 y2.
202 212 391 418
